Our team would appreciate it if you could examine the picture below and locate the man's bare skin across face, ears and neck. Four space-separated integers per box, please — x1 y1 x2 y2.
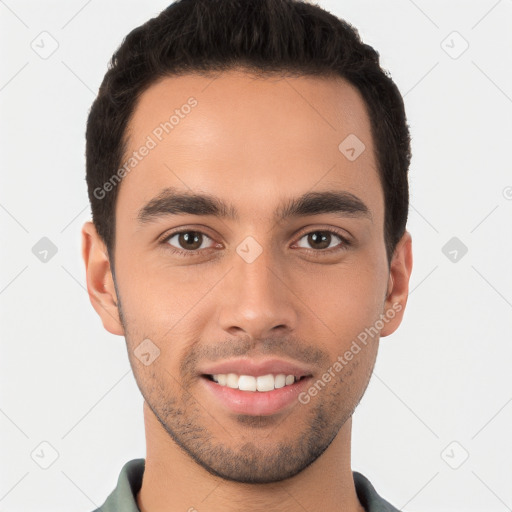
82 70 412 512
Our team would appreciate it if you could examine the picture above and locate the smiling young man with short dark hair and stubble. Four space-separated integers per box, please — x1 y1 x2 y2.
82 0 412 512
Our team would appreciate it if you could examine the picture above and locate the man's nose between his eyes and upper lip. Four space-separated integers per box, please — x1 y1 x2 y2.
218 243 298 339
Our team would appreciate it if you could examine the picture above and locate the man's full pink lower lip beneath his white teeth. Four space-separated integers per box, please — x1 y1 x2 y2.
201 377 311 416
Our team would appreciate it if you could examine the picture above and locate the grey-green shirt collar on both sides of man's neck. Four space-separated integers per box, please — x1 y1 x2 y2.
94 459 400 512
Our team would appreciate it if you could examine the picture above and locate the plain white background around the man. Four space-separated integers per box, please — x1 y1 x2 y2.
0 0 512 512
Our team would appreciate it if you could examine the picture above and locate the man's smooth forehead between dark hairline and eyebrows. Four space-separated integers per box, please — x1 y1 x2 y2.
116 71 383 224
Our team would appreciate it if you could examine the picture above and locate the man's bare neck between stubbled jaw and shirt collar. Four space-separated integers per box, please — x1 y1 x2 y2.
137 402 364 512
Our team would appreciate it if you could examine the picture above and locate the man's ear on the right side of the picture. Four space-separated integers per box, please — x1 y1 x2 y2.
380 231 412 337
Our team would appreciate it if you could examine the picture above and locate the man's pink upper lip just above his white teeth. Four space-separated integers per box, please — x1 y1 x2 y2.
200 358 311 377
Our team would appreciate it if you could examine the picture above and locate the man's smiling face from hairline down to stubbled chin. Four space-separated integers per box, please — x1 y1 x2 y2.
95 71 404 482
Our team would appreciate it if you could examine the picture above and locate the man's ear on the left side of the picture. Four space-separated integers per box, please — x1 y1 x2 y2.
82 221 124 336
